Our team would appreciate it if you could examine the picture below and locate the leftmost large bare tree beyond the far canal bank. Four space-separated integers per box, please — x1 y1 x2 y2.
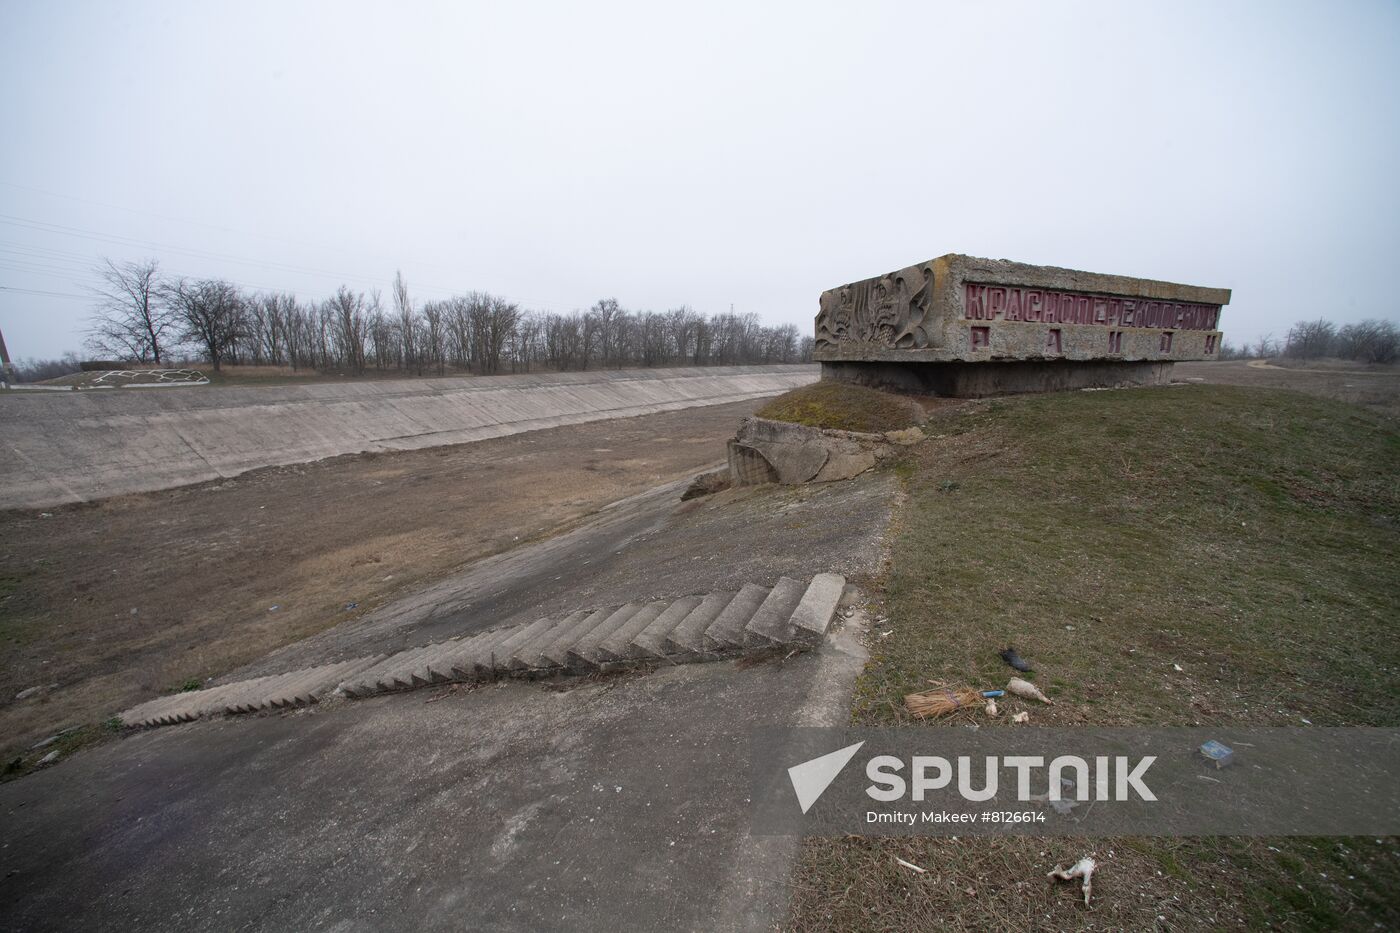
85 259 176 366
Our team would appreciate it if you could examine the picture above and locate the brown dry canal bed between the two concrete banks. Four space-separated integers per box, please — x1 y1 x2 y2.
0 399 763 749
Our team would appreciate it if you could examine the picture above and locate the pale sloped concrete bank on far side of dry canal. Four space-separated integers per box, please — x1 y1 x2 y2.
0 366 818 509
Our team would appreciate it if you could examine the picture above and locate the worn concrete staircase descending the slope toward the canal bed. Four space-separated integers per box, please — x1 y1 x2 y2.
120 573 846 726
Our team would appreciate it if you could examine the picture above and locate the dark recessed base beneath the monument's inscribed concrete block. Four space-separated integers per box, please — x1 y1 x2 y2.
822 360 1172 398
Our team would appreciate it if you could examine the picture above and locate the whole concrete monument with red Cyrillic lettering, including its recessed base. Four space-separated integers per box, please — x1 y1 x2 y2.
815 254 1231 396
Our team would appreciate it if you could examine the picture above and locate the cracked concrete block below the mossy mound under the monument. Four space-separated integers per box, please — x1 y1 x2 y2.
729 417 895 486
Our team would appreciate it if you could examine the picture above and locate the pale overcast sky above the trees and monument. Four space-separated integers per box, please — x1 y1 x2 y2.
0 0 1400 357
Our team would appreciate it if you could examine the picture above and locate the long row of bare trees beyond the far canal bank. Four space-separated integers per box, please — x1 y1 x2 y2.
87 259 812 375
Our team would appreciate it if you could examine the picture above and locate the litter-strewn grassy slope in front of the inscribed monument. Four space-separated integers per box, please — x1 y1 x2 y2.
790 385 1400 930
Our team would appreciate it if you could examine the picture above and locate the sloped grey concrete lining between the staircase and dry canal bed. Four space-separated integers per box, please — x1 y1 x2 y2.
220 472 897 682
